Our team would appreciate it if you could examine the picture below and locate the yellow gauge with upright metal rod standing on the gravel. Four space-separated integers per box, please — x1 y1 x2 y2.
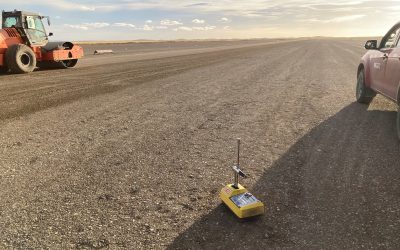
220 139 265 219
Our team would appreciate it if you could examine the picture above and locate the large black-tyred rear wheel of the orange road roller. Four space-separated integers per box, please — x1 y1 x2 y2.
6 44 36 74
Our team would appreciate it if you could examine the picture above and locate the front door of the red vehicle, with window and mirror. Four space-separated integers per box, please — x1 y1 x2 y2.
370 27 400 94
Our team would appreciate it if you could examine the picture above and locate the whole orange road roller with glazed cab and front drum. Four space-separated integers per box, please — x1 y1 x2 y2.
0 10 83 73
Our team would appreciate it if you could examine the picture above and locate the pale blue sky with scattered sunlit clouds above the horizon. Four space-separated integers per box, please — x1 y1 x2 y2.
0 0 400 41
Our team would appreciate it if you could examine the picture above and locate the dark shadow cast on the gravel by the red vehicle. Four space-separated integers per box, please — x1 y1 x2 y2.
168 103 400 249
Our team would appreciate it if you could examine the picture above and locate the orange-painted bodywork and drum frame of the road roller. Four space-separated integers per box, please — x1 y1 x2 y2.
0 28 83 67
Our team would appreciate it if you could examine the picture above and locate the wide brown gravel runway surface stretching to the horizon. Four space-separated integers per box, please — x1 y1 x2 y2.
0 38 400 249
